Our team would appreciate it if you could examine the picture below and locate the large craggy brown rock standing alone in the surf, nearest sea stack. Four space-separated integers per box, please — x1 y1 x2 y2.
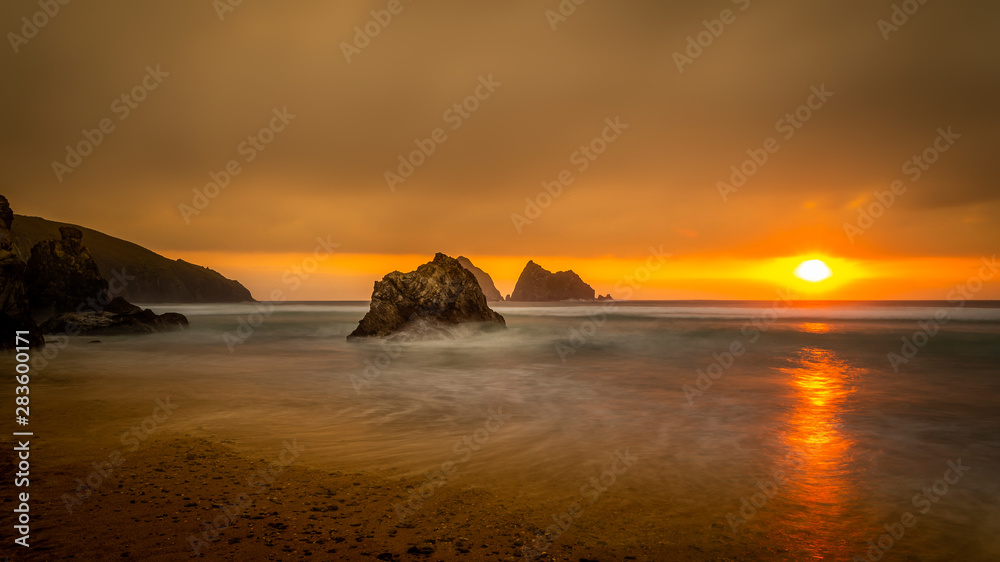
347 253 507 340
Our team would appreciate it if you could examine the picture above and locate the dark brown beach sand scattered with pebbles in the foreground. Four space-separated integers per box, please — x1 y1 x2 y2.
3 435 781 561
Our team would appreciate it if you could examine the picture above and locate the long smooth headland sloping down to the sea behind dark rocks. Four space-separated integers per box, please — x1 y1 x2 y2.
12 215 254 303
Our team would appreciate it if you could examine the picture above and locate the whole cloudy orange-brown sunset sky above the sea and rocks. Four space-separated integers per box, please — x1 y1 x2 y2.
0 0 1000 299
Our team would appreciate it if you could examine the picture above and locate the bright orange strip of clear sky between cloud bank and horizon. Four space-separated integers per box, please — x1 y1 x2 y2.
168 252 1000 300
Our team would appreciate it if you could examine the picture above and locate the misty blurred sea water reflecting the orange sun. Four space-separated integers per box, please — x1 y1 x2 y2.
13 302 1000 560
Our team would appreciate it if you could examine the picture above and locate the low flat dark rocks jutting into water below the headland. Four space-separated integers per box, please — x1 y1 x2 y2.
41 297 188 335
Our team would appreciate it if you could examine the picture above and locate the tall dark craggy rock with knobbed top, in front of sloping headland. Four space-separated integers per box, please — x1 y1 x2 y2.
25 226 108 314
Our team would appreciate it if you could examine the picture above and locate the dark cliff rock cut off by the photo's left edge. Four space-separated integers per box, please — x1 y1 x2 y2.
0 195 45 349
